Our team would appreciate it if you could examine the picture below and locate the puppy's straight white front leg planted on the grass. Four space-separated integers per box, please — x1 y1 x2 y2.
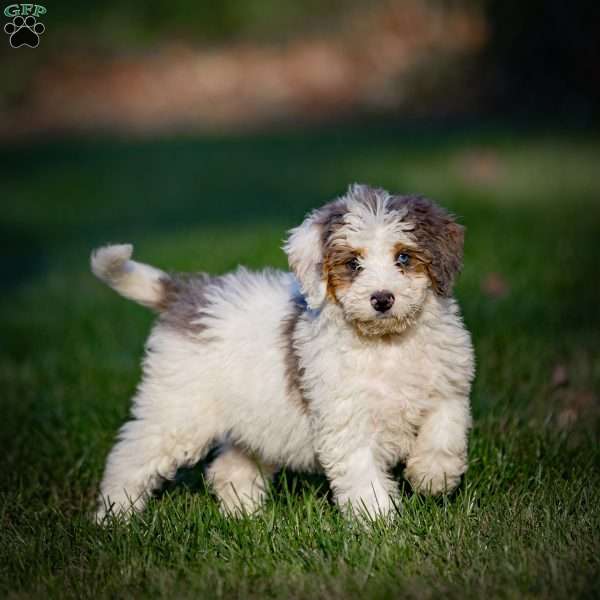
319 437 397 516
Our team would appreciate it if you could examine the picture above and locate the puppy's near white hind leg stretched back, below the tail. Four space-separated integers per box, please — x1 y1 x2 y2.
96 394 219 523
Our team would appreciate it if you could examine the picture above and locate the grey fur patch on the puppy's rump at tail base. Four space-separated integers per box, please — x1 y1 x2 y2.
159 273 221 334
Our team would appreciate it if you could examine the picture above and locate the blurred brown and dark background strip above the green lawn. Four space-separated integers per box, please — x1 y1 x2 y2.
0 0 600 139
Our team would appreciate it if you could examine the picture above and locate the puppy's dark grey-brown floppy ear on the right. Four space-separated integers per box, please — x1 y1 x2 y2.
398 196 465 296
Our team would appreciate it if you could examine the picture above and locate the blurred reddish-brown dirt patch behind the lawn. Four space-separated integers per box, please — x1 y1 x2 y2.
0 2 487 139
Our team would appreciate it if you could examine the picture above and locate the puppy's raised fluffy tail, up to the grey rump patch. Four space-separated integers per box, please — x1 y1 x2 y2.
91 244 170 311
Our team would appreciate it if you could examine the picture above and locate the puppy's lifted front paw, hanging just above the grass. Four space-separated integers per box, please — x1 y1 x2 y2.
404 452 467 496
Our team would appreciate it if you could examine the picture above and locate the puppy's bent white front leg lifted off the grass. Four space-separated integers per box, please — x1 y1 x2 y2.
404 398 471 494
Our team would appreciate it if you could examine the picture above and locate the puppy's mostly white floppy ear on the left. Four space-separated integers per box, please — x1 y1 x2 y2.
283 210 327 310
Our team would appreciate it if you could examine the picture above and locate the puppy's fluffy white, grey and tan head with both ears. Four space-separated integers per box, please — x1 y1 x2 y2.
285 185 464 336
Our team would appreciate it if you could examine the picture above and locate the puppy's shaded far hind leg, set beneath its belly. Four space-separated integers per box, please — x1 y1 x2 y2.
207 445 276 515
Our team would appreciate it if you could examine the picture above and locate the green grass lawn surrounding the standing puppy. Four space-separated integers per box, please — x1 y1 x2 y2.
0 124 600 599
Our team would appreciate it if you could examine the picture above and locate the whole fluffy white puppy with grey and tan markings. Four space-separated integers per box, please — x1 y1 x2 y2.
92 185 474 521
